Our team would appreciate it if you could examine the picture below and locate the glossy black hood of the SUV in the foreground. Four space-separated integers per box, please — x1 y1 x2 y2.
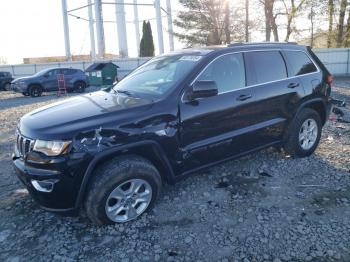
19 91 152 140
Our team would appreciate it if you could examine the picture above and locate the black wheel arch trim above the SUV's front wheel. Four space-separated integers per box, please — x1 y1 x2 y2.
75 141 176 208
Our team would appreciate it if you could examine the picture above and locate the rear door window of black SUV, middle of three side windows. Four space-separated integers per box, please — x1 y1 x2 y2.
245 51 287 84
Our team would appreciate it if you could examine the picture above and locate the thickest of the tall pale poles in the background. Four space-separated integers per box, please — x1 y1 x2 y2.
115 0 128 57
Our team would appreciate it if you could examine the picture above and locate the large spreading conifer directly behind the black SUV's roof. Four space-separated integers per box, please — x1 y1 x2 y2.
174 0 245 46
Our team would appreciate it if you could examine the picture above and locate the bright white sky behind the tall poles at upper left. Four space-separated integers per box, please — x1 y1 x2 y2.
0 0 183 64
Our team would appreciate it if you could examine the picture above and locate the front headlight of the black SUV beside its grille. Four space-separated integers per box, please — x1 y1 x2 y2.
33 140 71 156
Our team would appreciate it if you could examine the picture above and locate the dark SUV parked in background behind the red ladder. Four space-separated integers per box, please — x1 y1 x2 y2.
11 68 89 97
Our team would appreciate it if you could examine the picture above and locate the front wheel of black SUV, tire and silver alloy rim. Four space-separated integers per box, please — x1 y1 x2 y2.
84 155 162 225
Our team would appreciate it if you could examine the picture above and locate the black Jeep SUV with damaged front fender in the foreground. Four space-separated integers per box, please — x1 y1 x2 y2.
13 43 332 224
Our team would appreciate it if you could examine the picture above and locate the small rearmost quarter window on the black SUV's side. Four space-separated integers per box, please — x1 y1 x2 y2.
285 51 317 76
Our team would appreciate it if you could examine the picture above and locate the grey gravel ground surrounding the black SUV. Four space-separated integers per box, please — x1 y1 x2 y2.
0 82 350 262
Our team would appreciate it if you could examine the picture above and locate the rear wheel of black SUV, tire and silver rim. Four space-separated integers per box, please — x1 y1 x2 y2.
284 108 322 157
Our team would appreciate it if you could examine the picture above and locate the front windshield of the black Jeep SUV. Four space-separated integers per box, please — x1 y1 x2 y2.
113 54 202 97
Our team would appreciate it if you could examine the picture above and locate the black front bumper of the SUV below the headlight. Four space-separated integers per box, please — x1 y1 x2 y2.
13 149 90 215
